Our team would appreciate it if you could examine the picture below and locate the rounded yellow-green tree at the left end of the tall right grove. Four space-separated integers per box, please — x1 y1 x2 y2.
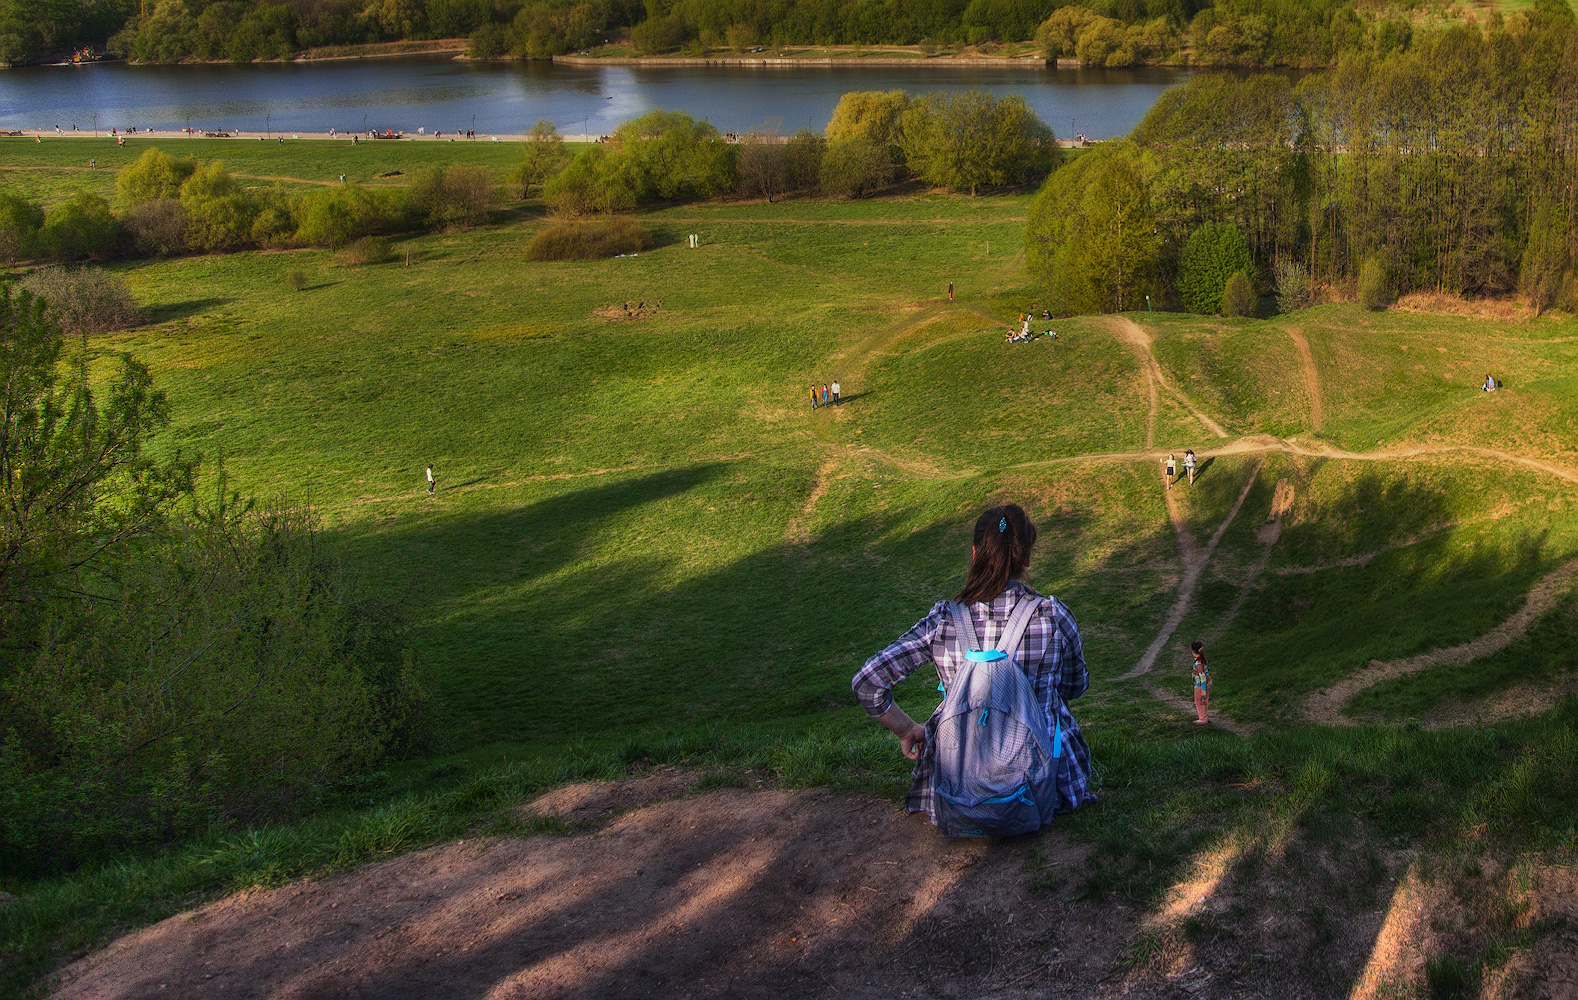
1024 142 1160 312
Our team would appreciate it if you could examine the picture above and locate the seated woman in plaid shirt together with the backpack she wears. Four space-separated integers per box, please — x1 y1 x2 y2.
851 503 1095 836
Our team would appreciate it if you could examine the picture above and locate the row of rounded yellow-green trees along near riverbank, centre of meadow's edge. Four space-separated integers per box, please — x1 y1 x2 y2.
533 90 1060 215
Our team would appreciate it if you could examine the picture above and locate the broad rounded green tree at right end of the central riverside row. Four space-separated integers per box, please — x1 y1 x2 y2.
899 90 1062 196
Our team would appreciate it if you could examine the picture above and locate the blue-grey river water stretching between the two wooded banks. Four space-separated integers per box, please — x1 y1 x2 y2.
0 57 1188 139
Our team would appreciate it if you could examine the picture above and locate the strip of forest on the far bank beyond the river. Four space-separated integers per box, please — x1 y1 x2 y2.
0 0 1567 66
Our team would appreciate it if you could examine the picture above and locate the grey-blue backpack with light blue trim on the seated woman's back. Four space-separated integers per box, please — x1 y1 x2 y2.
931 598 1062 838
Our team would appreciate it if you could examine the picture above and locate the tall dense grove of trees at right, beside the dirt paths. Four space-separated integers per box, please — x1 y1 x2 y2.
1027 17 1578 311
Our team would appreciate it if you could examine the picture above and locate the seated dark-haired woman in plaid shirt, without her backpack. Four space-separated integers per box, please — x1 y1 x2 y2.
851 503 1095 823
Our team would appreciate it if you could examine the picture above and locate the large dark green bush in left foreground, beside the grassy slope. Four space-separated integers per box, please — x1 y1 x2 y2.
0 290 420 879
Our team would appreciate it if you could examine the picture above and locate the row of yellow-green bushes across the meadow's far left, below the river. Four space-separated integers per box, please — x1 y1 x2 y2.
0 148 495 263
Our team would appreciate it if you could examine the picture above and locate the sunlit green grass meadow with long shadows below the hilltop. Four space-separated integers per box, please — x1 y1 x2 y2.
0 140 1578 996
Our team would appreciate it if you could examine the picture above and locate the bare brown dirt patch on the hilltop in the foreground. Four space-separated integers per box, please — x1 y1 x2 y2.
54 771 1477 1000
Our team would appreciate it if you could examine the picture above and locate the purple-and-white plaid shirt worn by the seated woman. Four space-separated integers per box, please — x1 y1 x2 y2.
851 580 1095 823
